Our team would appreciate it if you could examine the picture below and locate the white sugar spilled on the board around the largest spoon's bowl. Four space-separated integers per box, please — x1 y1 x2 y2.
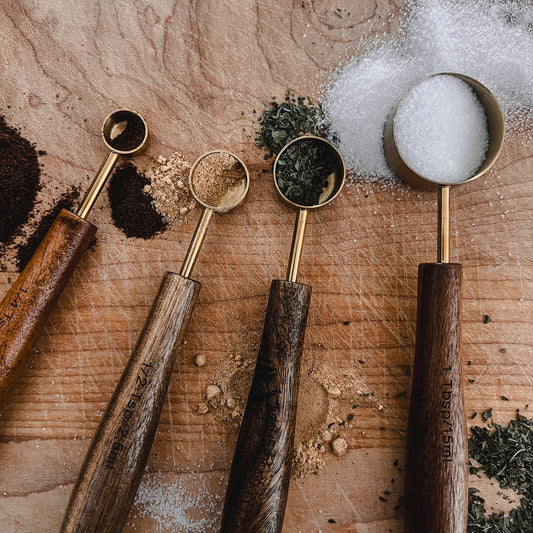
323 0 533 181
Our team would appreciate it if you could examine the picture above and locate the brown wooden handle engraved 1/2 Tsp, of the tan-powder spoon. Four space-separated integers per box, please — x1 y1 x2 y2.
61 272 200 533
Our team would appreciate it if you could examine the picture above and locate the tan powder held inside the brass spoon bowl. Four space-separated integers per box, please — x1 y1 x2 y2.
193 152 246 207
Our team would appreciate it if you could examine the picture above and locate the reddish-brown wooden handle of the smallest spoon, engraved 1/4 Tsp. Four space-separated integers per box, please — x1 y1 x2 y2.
0 209 96 402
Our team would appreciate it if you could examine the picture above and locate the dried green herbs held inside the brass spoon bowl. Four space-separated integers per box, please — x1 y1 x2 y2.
276 139 335 205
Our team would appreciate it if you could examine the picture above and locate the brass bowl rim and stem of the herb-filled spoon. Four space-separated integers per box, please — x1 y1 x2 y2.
272 135 346 282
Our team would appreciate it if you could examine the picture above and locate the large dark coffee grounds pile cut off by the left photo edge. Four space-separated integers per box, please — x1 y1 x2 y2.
0 116 45 245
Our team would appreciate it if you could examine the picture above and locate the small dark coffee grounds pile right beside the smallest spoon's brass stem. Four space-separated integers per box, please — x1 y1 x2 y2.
107 161 167 239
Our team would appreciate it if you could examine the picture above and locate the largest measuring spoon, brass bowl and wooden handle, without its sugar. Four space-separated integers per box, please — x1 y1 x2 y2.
384 73 504 533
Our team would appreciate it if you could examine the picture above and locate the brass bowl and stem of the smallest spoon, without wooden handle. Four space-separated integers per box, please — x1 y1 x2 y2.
76 109 148 218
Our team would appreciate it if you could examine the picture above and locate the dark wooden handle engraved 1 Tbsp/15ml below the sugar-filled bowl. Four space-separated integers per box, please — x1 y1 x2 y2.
405 263 467 533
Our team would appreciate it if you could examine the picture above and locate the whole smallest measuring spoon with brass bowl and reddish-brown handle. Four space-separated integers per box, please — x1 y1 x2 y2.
0 109 148 402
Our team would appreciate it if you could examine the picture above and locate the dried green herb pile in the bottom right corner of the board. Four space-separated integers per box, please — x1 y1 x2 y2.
468 414 533 533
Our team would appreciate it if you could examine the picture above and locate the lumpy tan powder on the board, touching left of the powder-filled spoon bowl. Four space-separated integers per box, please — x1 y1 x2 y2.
144 152 196 225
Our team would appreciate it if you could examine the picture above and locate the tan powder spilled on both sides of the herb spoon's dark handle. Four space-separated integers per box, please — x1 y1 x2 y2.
196 354 383 478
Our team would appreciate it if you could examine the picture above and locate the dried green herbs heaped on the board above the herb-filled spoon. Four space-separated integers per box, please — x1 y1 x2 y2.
255 91 326 159
